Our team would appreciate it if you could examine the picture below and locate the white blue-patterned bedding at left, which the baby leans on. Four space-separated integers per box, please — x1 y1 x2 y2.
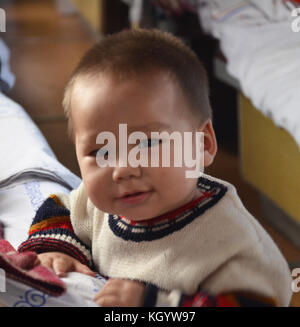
0 88 105 307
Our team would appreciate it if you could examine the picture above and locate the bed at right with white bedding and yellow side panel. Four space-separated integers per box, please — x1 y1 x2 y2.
199 0 300 248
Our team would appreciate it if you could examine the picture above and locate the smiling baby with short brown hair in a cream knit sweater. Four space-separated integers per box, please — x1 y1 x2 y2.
19 30 291 306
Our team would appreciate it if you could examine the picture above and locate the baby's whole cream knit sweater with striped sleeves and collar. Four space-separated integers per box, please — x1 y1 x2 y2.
19 175 291 306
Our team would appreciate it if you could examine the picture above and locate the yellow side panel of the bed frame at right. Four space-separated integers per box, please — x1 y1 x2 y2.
239 92 300 248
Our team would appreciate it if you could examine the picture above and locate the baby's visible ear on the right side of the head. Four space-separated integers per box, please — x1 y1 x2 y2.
198 119 218 167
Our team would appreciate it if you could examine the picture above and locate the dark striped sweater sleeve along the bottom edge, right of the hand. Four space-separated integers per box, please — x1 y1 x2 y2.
144 284 277 307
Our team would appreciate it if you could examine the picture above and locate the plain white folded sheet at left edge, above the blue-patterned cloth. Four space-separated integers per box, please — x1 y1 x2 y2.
0 93 80 189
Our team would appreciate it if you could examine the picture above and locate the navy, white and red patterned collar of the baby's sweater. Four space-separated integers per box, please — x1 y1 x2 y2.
108 177 227 242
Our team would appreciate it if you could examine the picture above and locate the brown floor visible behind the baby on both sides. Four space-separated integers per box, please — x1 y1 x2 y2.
1 0 300 306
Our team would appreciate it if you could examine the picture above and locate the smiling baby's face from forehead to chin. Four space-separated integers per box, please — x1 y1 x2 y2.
71 73 213 221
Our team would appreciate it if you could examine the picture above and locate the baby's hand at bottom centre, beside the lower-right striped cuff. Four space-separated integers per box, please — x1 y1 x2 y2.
94 279 145 307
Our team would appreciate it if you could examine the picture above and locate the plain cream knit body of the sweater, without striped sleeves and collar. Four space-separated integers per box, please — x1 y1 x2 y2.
59 175 292 306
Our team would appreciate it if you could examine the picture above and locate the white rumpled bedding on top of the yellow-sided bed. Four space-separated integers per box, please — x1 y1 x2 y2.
199 0 300 146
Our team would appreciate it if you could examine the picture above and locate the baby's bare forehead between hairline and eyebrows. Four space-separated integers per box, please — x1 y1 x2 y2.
71 73 197 143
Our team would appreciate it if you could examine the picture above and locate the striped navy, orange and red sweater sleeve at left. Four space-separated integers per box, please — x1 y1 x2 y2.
18 194 92 267
